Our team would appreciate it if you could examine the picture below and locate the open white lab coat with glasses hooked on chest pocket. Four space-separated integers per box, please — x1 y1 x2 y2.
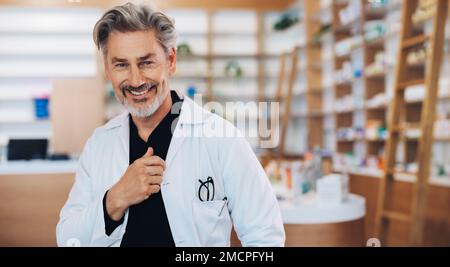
56 93 285 246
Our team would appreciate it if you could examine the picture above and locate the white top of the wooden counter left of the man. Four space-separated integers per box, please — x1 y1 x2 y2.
0 160 77 175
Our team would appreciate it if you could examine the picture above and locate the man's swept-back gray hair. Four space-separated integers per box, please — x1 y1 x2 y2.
93 3 177 55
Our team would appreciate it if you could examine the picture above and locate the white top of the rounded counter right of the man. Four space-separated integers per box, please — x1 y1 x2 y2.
279 194 366 224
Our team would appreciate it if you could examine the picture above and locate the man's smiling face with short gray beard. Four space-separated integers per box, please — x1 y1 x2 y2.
105 30 176 117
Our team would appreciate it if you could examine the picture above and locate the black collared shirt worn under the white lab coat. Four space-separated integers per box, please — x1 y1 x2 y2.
103 91 182 247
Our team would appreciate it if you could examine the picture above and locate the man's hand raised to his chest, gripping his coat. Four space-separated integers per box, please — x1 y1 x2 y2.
106 148 166 221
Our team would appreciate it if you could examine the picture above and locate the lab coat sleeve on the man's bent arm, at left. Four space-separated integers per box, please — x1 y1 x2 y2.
56 138 124 246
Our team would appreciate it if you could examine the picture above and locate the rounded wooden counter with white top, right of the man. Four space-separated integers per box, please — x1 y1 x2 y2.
231 194 366 247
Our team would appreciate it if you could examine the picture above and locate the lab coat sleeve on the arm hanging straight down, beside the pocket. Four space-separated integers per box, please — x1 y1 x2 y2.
220 132 285 247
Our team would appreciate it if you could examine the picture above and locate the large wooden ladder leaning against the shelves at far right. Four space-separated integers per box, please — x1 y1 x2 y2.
375 0 448 246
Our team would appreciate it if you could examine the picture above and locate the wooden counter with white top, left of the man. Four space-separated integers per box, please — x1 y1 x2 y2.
0 161 77 247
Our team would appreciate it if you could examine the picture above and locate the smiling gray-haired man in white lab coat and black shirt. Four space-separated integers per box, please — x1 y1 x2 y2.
57 3 285 247
